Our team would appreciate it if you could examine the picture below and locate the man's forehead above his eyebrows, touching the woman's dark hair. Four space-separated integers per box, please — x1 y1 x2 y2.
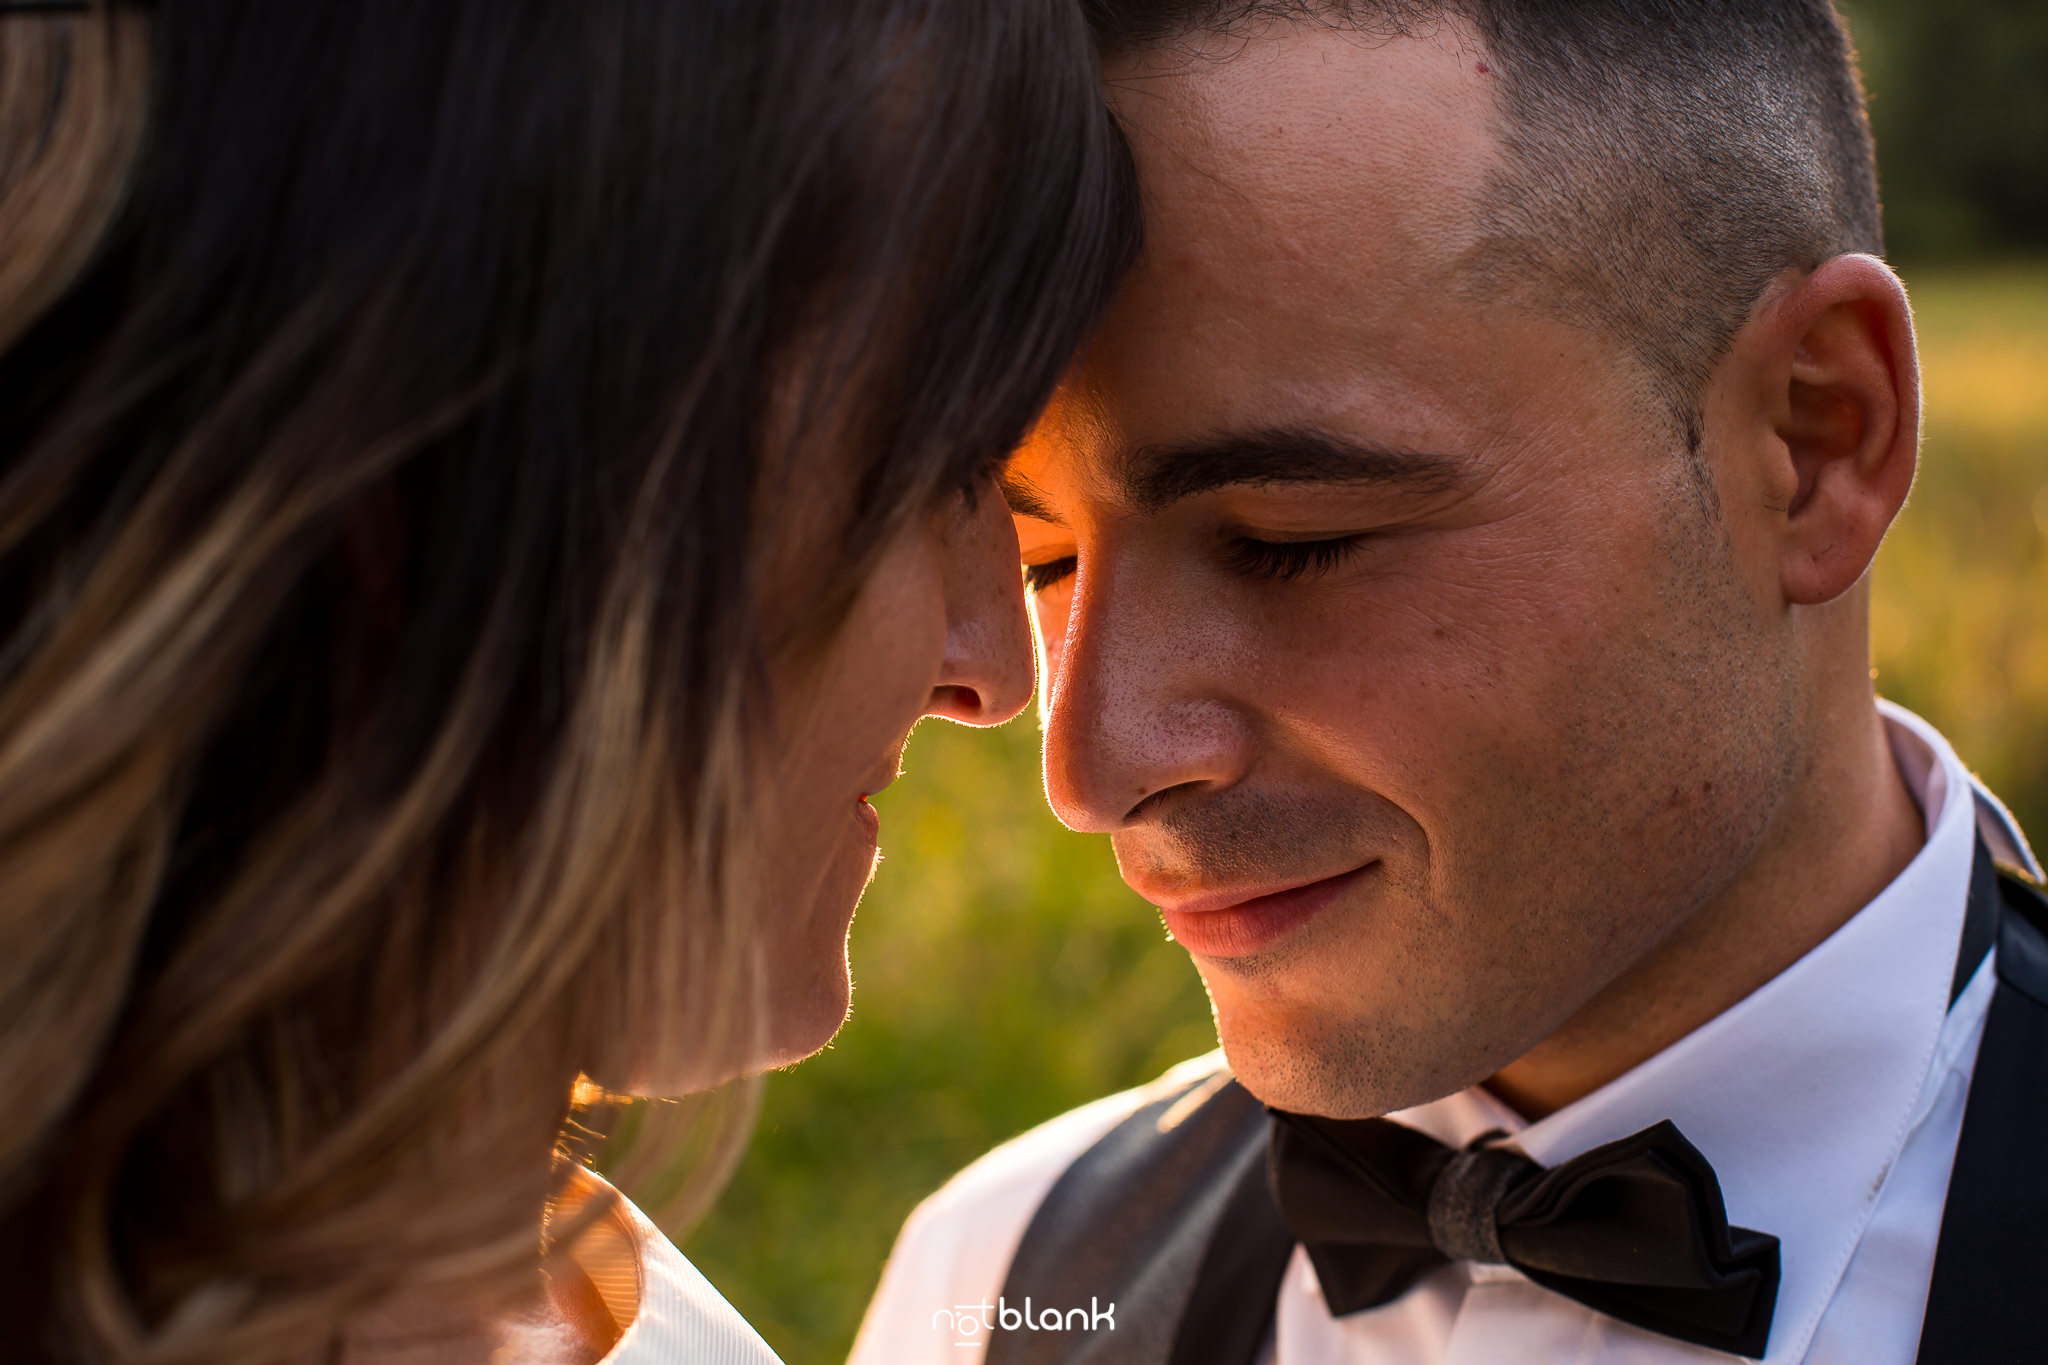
1064 23 1499 485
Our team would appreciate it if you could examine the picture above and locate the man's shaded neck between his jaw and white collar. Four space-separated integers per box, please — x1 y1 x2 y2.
1487 706 1933 1121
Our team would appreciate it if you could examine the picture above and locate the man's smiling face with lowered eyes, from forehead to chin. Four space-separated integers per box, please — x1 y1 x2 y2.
1010 25 1794 1115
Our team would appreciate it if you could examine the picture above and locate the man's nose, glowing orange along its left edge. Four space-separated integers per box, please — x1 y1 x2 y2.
1044 565 1251 833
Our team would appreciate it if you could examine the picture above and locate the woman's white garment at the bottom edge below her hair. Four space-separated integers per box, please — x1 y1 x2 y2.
557 1171 782 1365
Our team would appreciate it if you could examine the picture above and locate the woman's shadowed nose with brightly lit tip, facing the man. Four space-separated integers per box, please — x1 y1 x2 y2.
926 491 1034 724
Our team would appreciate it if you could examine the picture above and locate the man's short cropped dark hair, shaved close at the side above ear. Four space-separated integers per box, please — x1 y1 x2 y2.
1083 0 1884 450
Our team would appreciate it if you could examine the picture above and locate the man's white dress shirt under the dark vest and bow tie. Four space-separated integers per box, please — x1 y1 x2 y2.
852 704 2038 1365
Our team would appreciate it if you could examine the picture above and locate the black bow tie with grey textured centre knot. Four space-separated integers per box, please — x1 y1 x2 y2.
1270 1109 1778 1357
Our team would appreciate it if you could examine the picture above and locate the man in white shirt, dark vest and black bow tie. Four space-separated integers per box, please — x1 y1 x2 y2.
854 0 2048 1365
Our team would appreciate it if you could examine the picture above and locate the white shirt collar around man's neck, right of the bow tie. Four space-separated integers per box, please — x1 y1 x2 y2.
1389 704 1998 1361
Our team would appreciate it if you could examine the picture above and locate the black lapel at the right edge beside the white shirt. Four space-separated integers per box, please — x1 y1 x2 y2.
1919 878 2048 1365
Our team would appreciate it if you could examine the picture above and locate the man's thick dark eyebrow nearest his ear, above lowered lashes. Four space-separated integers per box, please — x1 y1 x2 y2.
1114 426 1470 514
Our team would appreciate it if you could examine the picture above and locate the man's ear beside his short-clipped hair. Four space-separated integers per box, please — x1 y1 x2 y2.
1751 256 1919 606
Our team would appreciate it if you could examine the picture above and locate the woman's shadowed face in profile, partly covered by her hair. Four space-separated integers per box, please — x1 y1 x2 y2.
756 479 1034 1066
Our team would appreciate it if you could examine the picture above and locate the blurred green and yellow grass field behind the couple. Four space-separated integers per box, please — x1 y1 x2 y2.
686 264 2048 1365
